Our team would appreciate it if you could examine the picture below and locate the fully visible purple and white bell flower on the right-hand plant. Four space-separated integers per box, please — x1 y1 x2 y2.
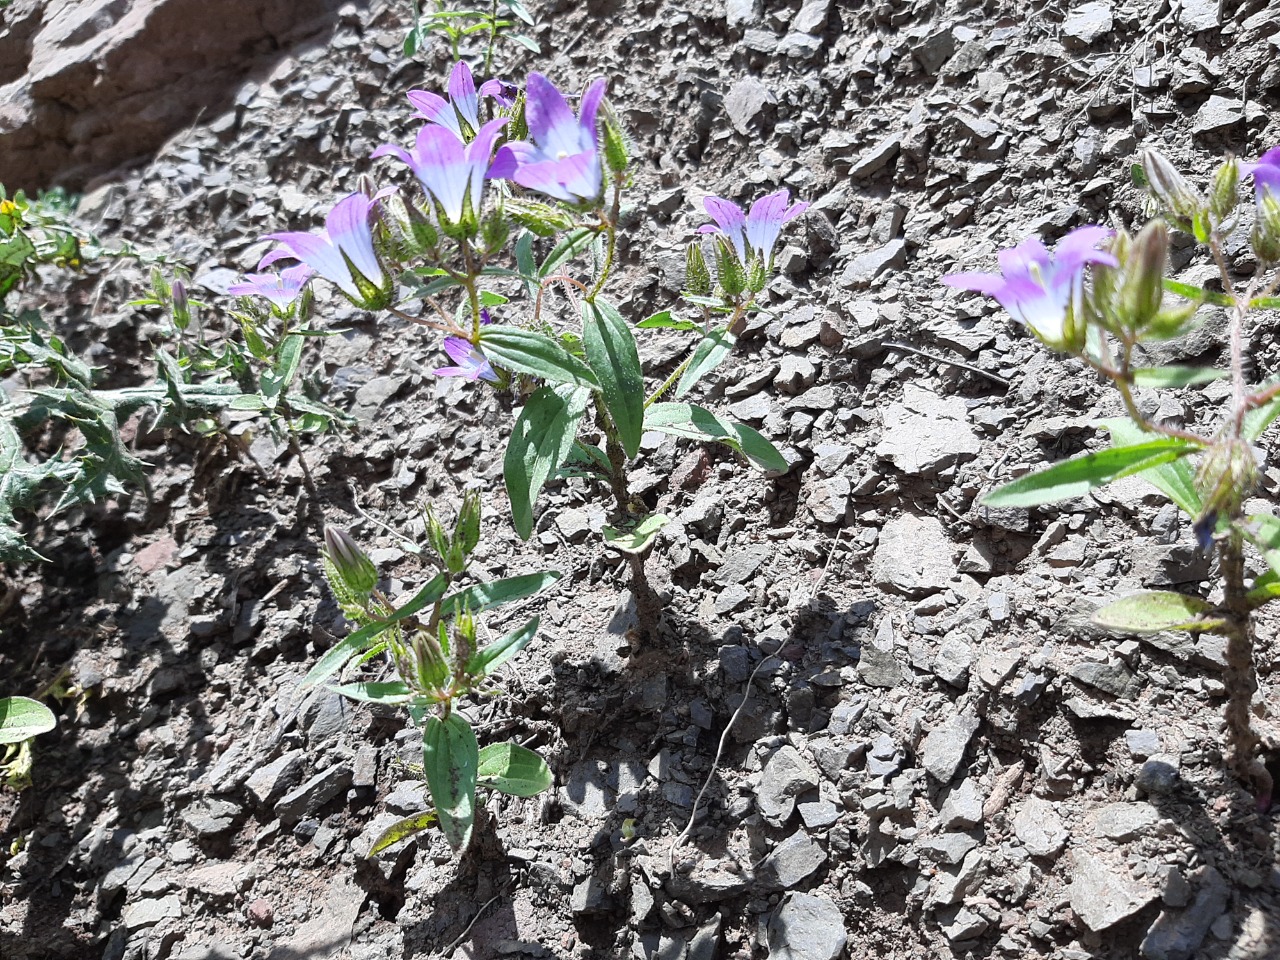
942 227 1120 349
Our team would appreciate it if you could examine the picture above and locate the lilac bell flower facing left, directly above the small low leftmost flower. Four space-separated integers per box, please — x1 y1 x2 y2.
257 192 390 305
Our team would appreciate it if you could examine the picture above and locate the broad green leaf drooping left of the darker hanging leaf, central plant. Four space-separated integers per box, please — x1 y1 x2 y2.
502 387 591 540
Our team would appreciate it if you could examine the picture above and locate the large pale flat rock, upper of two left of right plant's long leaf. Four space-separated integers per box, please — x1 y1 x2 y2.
876 384 982 476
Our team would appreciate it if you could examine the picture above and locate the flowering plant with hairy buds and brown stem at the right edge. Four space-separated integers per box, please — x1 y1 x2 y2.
945 147 1280 810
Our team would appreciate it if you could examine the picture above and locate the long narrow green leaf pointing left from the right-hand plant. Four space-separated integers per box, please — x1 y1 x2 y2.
982 436 1199 507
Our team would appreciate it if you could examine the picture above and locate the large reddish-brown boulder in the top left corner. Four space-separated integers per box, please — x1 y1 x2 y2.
0 0 342 189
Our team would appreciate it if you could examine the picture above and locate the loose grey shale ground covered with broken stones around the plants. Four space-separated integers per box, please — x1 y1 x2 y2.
0 0 1280 960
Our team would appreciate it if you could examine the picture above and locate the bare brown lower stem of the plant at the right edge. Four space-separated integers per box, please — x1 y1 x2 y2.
1219 527 1274 810
